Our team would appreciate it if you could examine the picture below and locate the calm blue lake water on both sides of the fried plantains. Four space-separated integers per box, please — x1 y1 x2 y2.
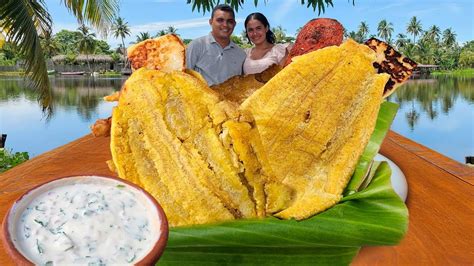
0 76 474 163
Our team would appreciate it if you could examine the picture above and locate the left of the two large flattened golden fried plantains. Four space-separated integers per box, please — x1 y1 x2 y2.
111 68 257 226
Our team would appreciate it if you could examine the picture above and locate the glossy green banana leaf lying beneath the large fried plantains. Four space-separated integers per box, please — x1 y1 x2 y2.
158 101 408 265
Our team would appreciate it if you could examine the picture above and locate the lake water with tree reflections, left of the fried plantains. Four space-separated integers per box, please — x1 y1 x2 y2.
0 76 125 157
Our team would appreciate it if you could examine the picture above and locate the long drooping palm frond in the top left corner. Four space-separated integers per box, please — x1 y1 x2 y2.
0 0 53 115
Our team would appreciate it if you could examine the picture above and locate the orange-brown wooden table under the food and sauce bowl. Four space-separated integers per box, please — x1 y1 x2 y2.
0 132 474 266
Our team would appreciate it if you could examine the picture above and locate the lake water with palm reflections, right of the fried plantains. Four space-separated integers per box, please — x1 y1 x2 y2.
388 77 474 163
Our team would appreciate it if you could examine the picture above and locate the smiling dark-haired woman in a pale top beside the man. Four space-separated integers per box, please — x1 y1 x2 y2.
243 12 287 75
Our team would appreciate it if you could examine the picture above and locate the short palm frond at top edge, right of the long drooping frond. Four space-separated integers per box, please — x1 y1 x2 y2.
62 0 119 36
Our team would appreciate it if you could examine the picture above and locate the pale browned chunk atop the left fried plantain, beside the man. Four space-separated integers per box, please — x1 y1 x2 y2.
127 34 185 72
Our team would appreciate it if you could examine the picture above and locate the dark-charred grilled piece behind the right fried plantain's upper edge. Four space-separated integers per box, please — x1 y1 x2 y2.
365 38 417 98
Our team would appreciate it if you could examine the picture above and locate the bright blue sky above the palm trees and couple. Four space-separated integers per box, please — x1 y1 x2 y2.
46 0 474 47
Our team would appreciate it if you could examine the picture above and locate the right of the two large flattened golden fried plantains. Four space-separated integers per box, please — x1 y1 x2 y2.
241 40 389 219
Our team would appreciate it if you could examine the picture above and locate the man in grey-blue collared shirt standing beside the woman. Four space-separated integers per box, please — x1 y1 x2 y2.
186 5 245 86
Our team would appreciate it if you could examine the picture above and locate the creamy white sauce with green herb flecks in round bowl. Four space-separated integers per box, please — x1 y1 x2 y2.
10 177 160 265
